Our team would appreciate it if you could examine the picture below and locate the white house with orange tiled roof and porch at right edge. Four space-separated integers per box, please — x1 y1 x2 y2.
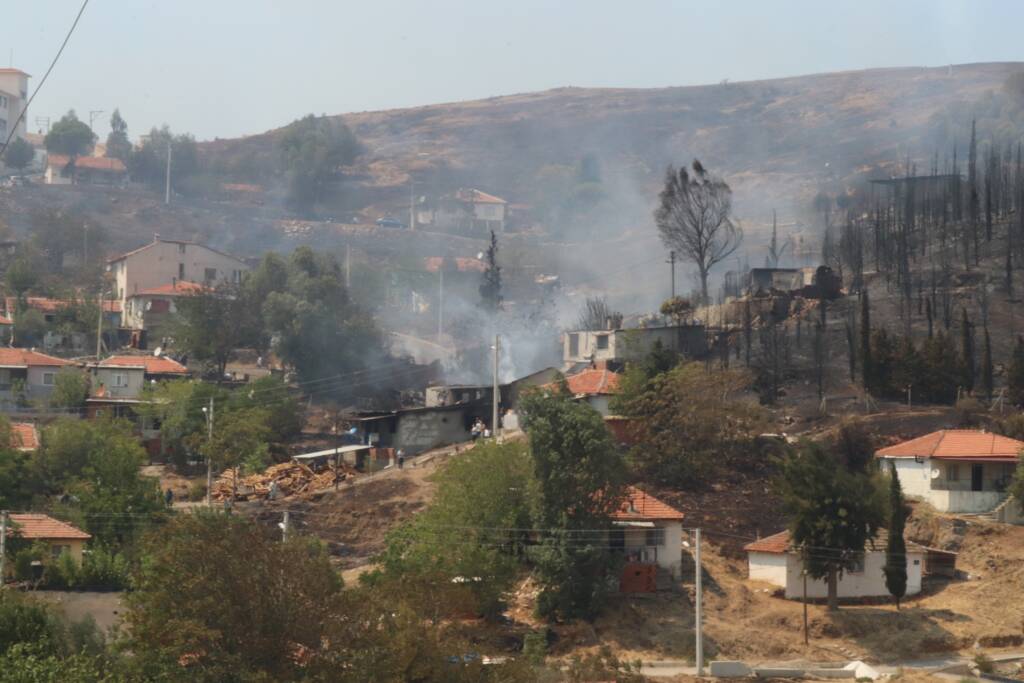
874 429 1024 513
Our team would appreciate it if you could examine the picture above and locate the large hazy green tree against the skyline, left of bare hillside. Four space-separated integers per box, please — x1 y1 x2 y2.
278 114 362 211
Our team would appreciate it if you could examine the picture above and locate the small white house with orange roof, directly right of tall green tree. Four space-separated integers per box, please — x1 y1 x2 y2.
608 486 683 579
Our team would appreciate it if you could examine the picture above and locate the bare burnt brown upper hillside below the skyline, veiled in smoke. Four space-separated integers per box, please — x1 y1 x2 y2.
206 62 1021 229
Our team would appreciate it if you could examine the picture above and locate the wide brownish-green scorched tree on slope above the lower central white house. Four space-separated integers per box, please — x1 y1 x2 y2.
612 362 766 488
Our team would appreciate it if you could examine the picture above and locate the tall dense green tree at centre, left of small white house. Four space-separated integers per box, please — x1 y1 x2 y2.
520 389 626 618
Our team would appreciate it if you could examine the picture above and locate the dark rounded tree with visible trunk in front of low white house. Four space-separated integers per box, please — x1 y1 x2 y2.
776 442 885 610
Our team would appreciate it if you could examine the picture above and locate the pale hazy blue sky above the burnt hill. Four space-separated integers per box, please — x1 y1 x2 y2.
0 0 1024 139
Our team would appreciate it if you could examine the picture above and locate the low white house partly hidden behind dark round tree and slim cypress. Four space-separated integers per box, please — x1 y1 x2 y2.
743 530 929 599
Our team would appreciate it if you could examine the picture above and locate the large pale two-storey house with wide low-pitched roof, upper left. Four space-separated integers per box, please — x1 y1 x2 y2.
106 234 249 315
